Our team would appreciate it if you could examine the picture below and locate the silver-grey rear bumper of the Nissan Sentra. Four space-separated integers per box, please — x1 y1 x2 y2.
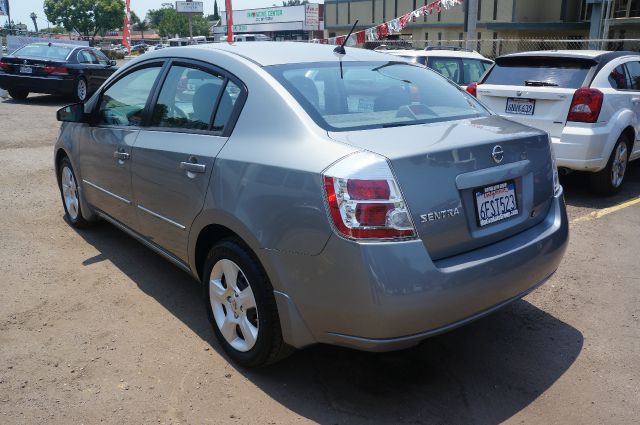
269 189 568 351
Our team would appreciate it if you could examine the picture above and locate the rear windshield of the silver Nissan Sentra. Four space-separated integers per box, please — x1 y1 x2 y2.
266 60 487 131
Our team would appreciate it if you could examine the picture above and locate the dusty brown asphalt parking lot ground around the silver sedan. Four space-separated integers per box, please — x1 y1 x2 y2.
0 95 640 424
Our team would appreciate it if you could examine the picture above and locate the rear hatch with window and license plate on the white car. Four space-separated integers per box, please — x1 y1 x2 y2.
477 56 596 137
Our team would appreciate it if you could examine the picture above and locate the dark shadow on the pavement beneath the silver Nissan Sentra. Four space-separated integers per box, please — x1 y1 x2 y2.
72 223 583 424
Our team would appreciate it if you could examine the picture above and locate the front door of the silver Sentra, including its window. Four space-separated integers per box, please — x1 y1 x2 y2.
78 63 162 229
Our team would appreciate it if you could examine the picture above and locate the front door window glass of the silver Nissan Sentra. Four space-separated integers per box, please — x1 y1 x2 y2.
98 65 160 127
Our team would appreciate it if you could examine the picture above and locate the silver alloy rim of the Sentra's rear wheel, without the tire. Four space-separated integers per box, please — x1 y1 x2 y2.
209 259 259 352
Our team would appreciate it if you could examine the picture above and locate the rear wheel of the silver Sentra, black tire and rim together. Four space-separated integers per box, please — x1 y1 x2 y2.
202 239 293 367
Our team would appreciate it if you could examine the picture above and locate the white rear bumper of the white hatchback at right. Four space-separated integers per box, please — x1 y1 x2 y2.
551 124 620 172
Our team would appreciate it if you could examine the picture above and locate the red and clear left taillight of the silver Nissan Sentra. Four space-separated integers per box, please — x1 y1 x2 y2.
323 152 416 239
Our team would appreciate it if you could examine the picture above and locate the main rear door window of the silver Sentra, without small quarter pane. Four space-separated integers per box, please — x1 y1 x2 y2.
151 65 224 130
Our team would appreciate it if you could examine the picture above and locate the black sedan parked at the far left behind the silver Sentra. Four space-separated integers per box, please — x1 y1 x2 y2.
0 43 117 101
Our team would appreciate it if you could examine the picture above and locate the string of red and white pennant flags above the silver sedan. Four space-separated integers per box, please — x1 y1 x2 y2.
320 0 463 46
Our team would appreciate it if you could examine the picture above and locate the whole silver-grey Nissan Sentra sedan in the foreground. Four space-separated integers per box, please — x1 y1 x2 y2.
55 42 568 366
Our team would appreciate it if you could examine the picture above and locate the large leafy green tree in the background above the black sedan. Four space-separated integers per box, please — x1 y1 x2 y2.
44 0 125 41
